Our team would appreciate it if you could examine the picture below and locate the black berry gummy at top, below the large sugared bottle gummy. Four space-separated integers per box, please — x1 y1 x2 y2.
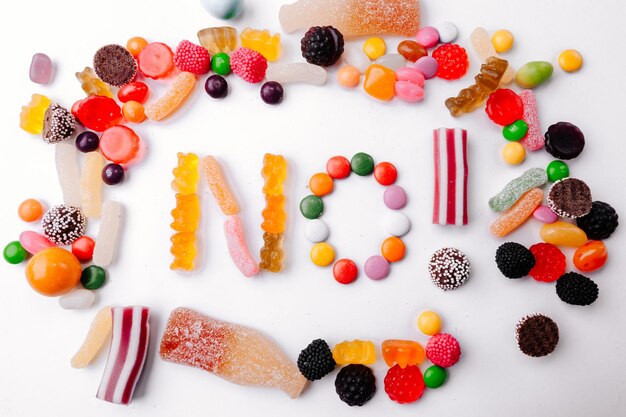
300 26 344 67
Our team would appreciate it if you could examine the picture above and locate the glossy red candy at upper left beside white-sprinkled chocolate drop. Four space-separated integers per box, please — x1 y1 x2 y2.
72 96 122 132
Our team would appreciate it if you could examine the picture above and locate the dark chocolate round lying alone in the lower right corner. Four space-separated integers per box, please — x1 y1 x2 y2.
515 313 559 358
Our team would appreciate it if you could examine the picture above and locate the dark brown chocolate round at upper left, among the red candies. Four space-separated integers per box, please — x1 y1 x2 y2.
93 45 137 87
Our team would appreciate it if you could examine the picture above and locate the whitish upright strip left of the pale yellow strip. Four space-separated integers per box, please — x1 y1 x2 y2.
54 142 82 207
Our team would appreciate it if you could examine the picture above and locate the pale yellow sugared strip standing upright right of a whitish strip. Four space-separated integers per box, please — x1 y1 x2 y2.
80 151 105 219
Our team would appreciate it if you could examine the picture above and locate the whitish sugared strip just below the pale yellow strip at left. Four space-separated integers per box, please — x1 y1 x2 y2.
93 201 122 268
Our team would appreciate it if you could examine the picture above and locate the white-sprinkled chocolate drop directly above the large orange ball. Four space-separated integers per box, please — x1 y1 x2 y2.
41 204 87 245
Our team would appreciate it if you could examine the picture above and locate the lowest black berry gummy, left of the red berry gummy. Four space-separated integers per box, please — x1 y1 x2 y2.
335 364 376 407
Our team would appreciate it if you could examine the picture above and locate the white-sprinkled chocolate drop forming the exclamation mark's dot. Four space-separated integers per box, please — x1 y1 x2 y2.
428 248 470 291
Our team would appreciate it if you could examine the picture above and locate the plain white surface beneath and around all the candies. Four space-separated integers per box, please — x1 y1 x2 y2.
0 0 626 417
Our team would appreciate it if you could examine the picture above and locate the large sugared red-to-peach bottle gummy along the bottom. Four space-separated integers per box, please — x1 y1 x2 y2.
160 308 307 398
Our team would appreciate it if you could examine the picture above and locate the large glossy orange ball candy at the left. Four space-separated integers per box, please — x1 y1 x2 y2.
26 248 82 297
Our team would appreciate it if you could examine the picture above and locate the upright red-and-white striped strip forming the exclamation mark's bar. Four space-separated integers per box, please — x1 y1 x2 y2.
433 127 468 226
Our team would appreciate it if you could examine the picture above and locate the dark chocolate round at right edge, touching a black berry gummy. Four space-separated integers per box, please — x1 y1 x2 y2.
548 178 593 219
